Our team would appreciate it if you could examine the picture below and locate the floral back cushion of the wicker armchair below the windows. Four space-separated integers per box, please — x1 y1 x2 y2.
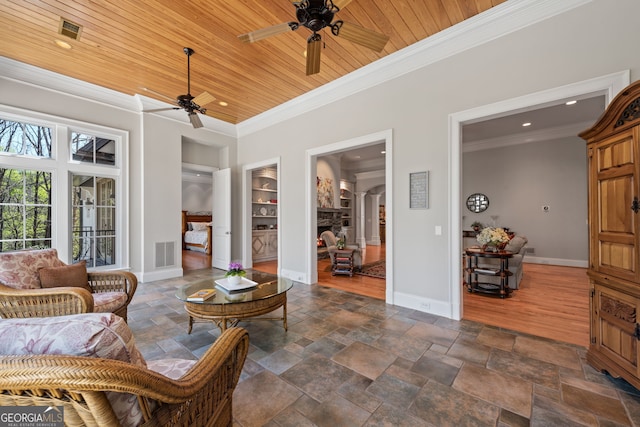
0 249 65 289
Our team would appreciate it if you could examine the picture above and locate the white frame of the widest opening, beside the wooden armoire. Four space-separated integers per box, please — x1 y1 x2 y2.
449 70 631 320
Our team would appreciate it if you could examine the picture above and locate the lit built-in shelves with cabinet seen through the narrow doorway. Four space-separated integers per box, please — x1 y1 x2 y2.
251 167 278 262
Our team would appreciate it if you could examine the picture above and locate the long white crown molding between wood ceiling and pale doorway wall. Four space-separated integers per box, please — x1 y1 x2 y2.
237 0 593 137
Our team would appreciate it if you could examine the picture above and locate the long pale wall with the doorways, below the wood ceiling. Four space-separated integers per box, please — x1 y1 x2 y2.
239 0 640 307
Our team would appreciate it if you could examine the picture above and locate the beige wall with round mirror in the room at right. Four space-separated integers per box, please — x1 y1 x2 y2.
461 137 589 266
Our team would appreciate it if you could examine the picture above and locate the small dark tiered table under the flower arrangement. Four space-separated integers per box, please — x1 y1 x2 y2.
464 249 513 298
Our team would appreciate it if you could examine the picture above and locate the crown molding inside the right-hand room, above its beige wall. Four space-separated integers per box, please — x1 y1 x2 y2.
462 122 593 153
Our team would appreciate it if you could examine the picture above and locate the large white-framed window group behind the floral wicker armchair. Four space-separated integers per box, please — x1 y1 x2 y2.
0 111 129 269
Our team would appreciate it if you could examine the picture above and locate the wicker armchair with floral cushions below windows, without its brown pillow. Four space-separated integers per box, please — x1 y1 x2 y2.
0 249 138 321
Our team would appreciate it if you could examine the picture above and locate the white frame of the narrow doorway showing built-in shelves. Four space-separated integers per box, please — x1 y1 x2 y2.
242 157 282 275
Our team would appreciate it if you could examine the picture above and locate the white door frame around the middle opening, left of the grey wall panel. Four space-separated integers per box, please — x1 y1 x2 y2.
305 129 393 304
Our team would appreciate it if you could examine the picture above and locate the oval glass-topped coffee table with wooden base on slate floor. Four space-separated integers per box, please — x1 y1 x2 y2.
176 270 293 333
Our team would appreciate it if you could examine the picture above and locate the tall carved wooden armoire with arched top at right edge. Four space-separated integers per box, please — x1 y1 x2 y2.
580 81 640 388
